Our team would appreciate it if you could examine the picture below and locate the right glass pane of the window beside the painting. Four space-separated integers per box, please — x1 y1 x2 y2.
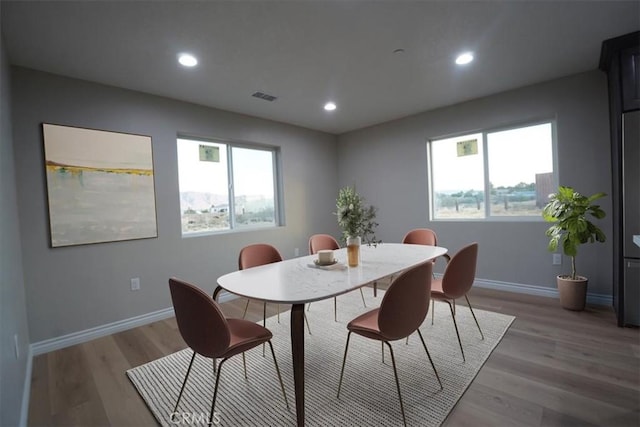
231 147 276 228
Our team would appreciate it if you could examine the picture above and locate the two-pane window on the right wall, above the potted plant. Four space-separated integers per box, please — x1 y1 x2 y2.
427 122 557 220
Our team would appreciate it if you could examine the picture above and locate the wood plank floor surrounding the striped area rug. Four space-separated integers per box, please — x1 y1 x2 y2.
28 288 640 427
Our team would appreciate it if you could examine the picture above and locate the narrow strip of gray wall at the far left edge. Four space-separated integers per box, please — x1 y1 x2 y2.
0 24 29 426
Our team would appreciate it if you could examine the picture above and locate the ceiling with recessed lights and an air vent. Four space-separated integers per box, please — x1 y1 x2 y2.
0 0 640 134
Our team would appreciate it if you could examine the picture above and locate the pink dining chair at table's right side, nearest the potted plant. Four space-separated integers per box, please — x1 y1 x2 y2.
431 242 484 360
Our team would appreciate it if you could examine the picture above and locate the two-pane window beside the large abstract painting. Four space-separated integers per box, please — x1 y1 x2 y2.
178 138 279 235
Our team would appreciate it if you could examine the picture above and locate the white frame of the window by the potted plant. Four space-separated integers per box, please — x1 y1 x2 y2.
426 117 559 222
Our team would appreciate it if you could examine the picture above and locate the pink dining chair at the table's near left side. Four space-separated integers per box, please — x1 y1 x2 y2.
169 278 289 420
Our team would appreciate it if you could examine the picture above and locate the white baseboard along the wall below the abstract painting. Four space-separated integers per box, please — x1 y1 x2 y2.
29 292 237 356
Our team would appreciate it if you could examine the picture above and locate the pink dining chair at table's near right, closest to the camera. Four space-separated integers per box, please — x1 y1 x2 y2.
338 262 442 425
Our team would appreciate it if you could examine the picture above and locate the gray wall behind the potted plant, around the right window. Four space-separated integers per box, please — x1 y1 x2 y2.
338 71 612 297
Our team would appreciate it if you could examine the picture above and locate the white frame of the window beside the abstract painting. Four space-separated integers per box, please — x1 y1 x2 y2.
176 133 284 238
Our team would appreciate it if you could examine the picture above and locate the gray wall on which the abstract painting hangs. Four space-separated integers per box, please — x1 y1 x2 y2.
12 68 337 342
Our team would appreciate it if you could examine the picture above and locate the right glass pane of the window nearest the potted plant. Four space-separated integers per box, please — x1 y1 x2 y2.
487 123 553 217
